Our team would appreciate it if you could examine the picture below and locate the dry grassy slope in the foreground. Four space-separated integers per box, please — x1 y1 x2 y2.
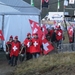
14 53 75 75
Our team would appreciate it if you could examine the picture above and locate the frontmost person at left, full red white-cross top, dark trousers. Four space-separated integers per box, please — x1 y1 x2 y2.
10 36 21 66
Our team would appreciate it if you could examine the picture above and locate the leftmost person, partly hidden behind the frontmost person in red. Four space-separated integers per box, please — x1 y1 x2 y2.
6 35 13 64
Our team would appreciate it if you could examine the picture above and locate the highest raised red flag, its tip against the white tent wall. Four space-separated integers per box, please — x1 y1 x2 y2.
29 20 42 38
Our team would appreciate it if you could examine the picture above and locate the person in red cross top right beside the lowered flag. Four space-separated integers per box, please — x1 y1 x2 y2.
30 33 42 58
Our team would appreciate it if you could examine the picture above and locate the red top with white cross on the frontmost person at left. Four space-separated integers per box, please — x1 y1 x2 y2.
10 42 21 57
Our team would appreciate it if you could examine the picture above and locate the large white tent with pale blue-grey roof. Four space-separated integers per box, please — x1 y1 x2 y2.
0 0 40 50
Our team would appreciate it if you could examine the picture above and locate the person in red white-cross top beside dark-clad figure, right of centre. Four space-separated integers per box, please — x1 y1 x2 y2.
56 26 63 48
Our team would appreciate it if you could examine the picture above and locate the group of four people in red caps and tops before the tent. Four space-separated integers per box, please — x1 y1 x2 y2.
6 33 42 66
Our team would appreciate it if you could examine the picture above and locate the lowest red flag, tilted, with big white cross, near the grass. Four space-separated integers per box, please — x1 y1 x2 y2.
42 39 54 55
